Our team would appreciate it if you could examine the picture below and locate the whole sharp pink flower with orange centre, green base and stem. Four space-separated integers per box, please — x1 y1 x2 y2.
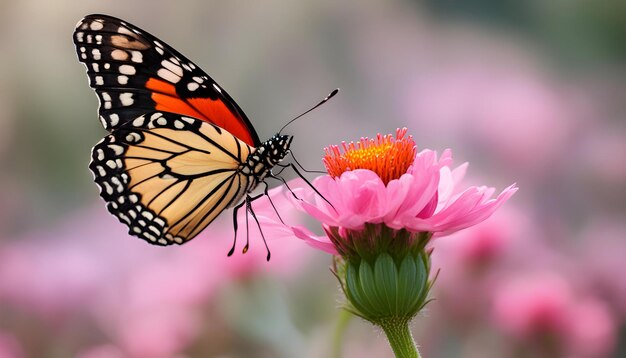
276 128 517 356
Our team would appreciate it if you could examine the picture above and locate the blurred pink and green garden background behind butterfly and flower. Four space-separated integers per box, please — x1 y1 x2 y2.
0 0 626 358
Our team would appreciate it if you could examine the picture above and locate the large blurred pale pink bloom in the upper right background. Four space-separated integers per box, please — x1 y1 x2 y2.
404 64 576 174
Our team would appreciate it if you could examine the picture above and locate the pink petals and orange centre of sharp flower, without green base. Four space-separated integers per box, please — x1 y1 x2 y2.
292 129 517 254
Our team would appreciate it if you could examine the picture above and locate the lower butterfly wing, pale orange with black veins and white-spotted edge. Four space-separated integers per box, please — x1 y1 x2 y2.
89 112 252 245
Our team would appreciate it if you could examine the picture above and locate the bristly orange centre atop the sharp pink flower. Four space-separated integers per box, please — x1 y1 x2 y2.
323 128 417 185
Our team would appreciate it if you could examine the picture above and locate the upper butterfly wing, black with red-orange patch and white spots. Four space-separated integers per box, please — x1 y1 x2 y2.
74 15 260 147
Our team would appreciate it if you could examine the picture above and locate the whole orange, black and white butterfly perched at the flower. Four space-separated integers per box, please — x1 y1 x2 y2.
73 15 293 252
